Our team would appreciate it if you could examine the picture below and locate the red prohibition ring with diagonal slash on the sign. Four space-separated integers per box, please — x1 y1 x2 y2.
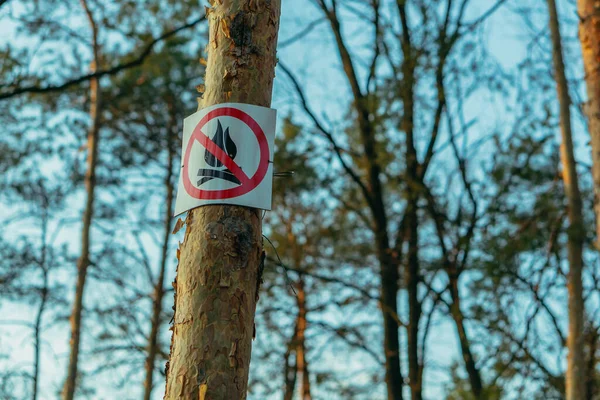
182 107 269 200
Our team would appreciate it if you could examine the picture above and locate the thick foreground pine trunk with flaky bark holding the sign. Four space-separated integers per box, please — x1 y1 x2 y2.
165 0 281 400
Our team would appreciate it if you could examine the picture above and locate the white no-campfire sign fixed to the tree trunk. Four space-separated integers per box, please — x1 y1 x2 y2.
175 103 277 215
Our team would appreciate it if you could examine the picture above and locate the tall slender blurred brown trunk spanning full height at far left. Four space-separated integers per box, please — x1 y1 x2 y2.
63 0 101 400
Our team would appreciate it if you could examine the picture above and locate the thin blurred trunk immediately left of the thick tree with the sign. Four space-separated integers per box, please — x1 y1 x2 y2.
144 101 177 400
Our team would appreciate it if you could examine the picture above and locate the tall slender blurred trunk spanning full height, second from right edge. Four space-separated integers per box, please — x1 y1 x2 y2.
548 0 585 400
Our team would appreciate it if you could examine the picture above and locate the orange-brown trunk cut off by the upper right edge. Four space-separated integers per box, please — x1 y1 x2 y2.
578 0 600 249
